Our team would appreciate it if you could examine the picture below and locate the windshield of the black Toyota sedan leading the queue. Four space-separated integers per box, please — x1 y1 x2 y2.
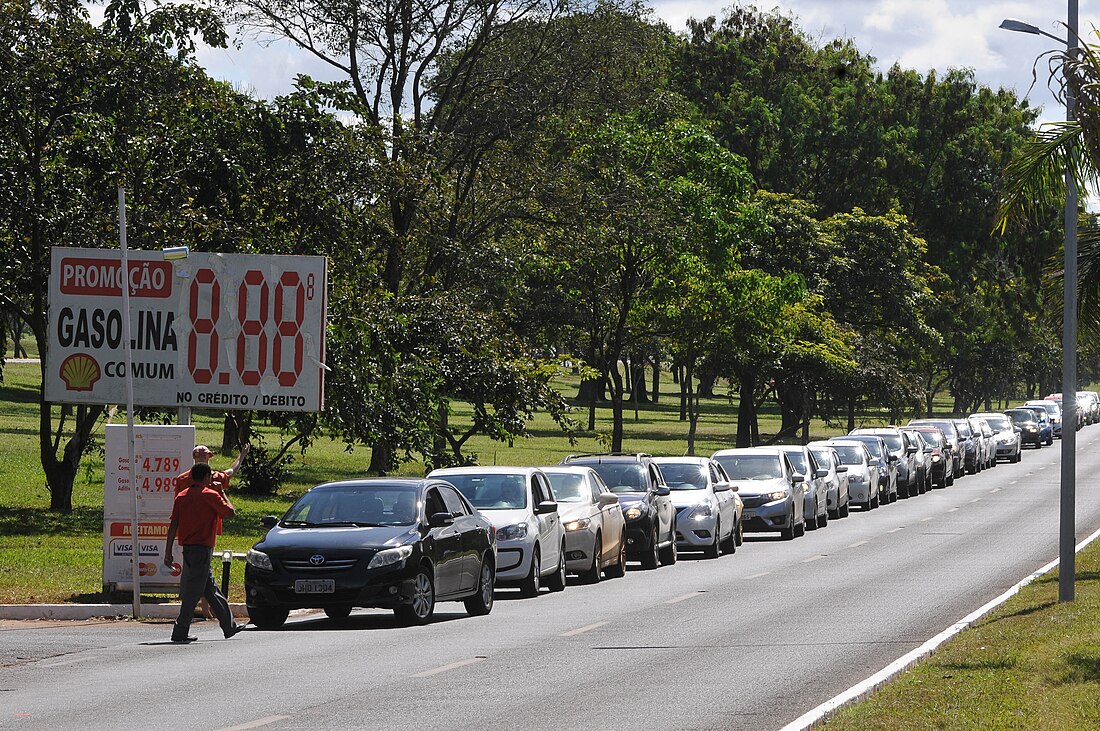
283 485 419 528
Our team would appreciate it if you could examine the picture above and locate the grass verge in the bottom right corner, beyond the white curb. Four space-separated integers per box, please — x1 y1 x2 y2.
824 543 1100 731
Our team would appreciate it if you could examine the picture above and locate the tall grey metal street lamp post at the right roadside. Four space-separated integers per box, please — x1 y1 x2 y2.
1000 0 1078 601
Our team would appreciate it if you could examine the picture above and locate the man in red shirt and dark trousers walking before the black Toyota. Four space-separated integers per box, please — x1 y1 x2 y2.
164 463 244 643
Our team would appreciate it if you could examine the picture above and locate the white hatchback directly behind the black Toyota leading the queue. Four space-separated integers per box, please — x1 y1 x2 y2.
428 467 565 597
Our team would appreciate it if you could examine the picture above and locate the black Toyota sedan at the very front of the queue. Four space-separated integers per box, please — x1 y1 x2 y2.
244 478 496 629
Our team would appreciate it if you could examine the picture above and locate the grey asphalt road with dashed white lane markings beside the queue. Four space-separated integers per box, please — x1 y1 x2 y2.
0 427 1100 731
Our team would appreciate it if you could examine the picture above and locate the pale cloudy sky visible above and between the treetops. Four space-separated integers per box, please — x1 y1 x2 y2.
182 0 1100 120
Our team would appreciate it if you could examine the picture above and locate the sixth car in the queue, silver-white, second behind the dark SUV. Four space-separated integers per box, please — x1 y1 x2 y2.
711 446 806 541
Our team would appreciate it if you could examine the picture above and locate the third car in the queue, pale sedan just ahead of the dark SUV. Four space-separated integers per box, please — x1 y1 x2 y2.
542 465 626 584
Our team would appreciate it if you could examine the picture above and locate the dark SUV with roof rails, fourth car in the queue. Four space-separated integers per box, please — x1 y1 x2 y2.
561 452 677 568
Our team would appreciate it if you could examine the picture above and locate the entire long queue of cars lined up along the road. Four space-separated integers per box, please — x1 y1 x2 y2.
245 398 1100 629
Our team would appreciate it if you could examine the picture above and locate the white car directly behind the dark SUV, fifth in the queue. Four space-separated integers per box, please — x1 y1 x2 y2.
653 457 745 558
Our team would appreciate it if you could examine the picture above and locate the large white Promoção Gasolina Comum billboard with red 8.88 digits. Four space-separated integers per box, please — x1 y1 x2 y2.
45 246 328 411
